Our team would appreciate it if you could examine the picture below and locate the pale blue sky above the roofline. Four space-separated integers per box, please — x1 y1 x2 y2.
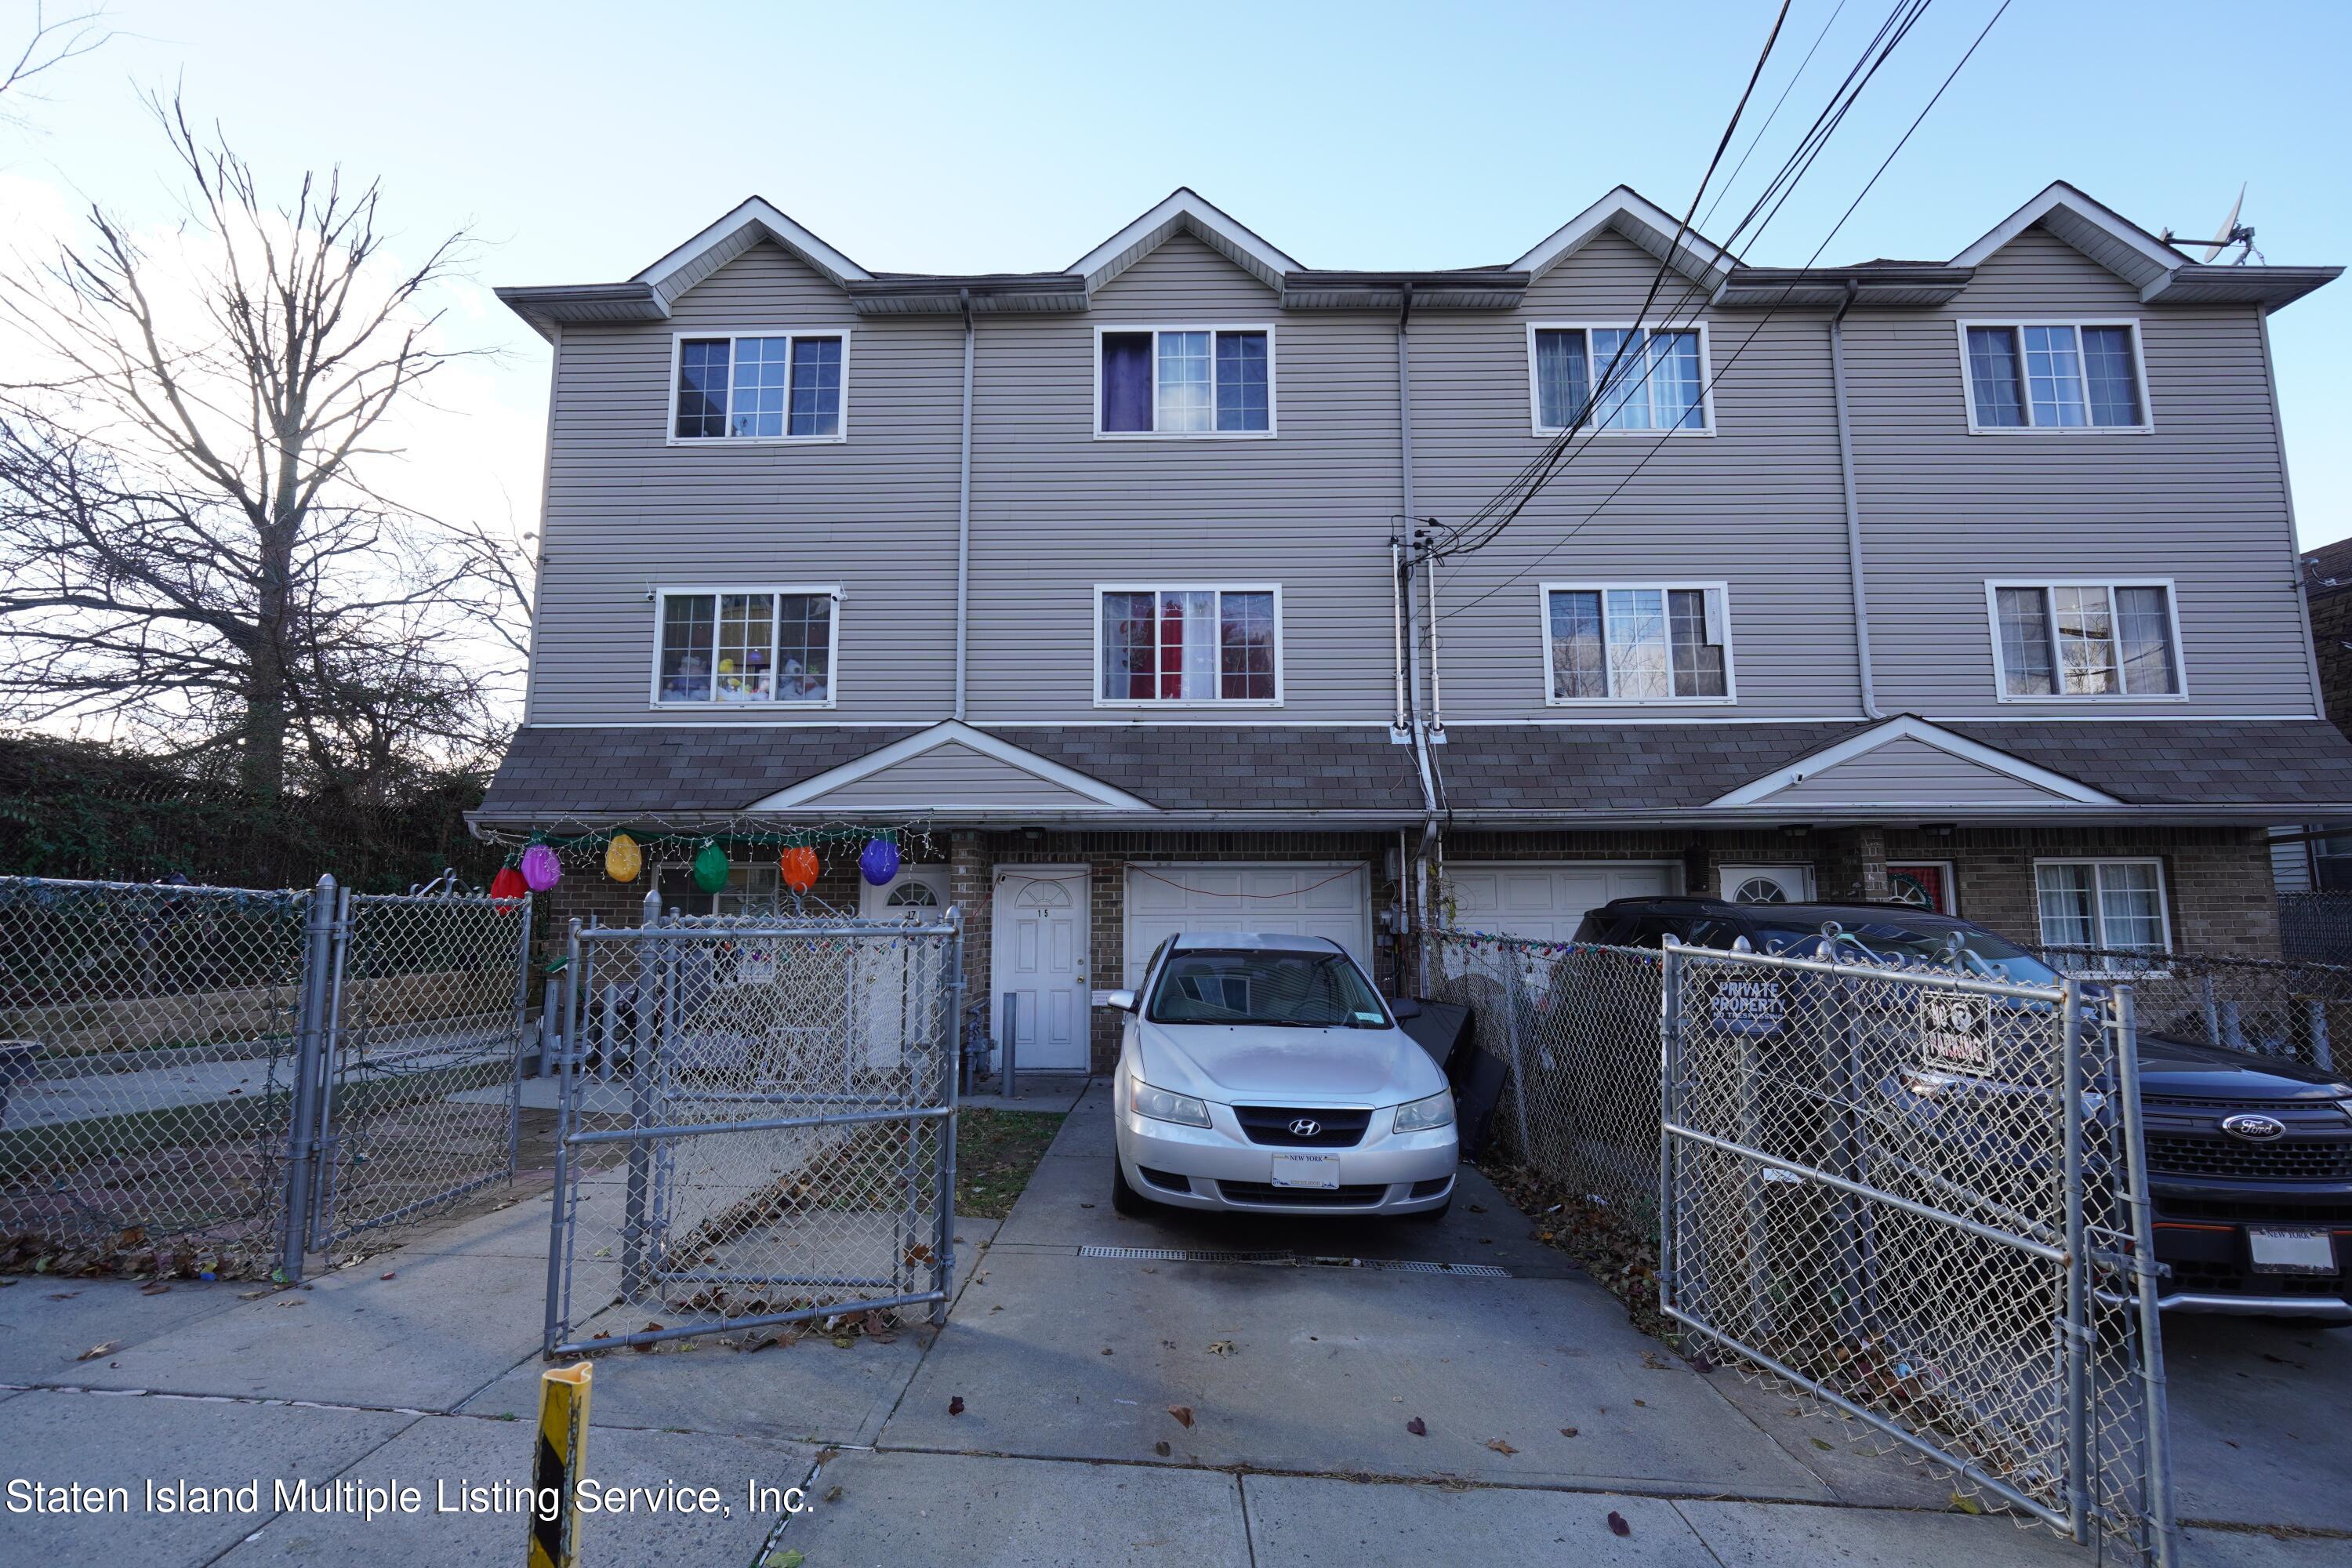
0 0 2352 546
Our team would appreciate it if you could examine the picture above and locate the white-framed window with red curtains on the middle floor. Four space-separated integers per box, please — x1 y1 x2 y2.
1094 583 1282 708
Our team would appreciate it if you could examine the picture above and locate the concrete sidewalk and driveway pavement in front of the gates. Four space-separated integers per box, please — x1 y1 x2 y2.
0 1088 2352 1568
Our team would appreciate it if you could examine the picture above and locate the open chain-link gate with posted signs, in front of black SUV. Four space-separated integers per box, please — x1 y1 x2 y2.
1658 942 2173 1563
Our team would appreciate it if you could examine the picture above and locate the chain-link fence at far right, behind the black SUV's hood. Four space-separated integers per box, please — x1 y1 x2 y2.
2030 947 2352 1072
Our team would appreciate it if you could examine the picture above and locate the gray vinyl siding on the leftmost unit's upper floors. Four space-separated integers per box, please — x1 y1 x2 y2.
532 245 964 724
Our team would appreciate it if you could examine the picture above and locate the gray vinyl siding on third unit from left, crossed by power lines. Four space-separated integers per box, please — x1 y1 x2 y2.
1414 233 1860 724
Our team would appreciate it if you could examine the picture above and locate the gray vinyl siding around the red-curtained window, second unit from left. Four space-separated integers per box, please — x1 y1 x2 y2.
969 235 1397 724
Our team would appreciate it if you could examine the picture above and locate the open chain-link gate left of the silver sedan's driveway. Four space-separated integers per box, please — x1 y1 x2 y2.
543 895 962 1359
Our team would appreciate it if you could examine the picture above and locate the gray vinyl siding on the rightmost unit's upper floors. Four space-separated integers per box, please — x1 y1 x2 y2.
1846 228 2314 717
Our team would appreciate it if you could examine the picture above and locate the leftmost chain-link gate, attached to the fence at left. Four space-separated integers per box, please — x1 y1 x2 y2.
310 893 532 1248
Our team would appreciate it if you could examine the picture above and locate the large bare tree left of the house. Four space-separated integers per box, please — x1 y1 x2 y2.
0 99 496 797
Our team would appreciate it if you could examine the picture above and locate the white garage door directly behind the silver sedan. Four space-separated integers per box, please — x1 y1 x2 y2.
1124 860 1371 985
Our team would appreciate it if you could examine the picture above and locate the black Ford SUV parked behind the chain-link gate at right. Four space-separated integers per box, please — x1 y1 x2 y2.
1576 898 2352 1326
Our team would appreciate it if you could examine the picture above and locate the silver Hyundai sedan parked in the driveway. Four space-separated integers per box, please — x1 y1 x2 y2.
1103 933 1458 1218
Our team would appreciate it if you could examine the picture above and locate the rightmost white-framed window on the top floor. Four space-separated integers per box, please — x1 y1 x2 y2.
1959 322 2152 435
